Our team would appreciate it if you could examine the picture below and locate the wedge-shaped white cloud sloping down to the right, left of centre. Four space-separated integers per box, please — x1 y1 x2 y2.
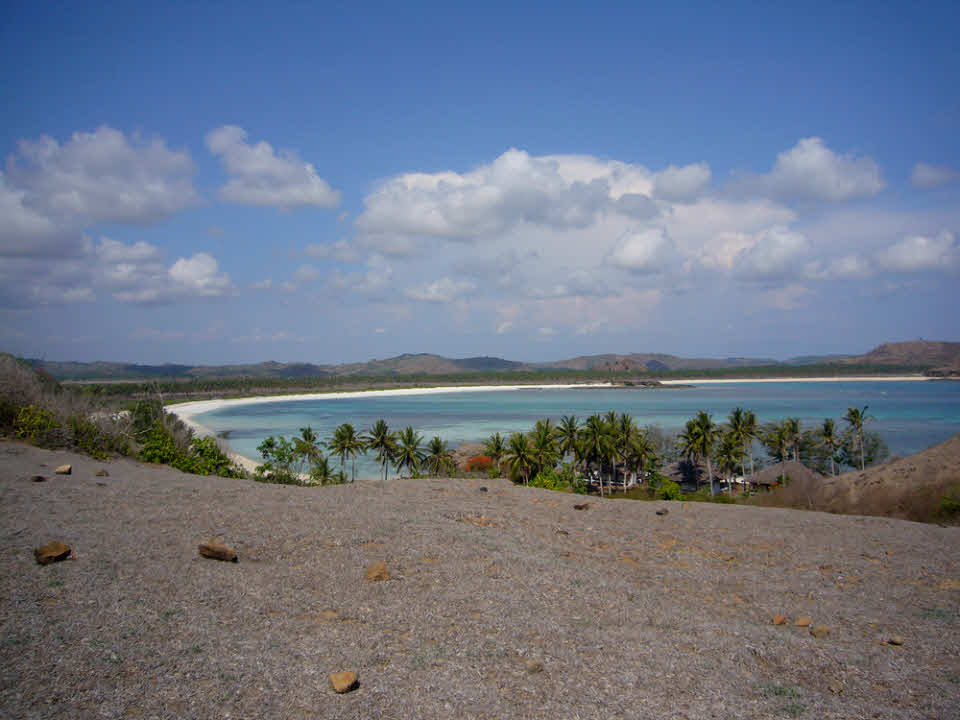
206 125 340 209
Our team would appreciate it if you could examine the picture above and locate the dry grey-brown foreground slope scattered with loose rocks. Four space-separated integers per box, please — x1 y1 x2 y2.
0 443 960 718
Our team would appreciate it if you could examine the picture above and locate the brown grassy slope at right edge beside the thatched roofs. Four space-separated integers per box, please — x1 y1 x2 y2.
760 435 960 522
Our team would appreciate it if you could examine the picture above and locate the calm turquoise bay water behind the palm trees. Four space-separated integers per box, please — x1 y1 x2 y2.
194 382 960 476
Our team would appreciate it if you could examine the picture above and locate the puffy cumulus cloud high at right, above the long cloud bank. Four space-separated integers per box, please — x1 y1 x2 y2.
734 137 886 202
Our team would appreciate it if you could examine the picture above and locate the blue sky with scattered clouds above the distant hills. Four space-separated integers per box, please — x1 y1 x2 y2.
0 2 960 363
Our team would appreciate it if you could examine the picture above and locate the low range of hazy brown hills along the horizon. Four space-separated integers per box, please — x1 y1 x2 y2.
31 340 960 380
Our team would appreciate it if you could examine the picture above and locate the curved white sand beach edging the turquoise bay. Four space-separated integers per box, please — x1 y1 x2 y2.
166 375 932 472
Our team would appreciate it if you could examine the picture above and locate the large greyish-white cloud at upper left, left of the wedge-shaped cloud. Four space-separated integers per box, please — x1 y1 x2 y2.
7 125 197 227
